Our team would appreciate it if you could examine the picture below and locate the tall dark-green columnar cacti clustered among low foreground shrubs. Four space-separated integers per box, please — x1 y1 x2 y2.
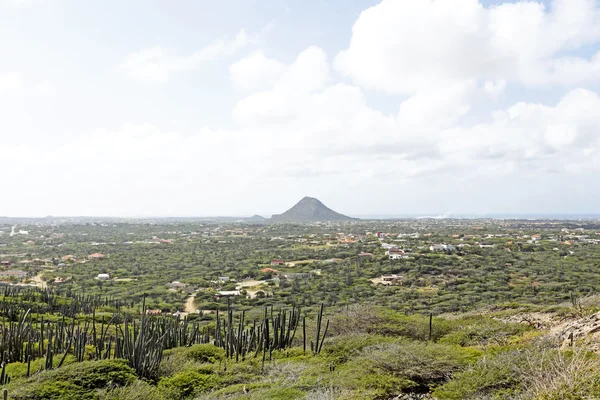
0 288 329 385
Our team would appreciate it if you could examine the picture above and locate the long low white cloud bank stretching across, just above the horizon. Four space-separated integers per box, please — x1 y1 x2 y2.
0 84 600 215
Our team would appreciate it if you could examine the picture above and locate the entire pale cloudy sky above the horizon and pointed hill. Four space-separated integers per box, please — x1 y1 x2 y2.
0 0 600 217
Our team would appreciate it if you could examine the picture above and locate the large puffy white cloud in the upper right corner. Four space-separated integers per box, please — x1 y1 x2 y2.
335 0 600 93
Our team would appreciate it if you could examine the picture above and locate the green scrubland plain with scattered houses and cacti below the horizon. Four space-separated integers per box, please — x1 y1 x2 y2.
0 219 600 399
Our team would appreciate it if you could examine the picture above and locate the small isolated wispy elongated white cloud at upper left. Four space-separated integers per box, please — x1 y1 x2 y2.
118 30 256 83
